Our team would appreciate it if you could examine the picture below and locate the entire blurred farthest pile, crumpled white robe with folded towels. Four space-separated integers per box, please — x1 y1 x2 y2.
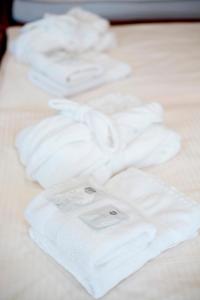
10 8 131 96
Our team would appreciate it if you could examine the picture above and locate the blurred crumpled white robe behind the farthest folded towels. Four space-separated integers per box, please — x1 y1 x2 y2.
10 8 116 63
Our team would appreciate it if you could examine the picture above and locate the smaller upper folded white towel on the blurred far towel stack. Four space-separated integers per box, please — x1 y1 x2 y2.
31 50 104 87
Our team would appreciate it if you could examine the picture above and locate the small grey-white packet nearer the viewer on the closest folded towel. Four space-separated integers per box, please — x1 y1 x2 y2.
79 205 128 229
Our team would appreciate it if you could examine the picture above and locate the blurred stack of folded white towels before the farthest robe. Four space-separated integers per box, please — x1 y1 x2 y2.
29 50 131 96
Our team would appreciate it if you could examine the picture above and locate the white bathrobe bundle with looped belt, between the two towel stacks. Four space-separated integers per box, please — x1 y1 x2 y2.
16 94 180 187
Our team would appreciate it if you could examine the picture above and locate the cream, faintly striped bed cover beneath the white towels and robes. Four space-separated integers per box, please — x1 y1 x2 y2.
0 23 200 300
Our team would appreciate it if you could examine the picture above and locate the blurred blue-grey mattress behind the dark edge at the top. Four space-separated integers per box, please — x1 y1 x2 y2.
13 0 200 22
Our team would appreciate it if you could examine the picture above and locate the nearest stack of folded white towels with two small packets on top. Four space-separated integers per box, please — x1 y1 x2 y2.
26 169 200 298
